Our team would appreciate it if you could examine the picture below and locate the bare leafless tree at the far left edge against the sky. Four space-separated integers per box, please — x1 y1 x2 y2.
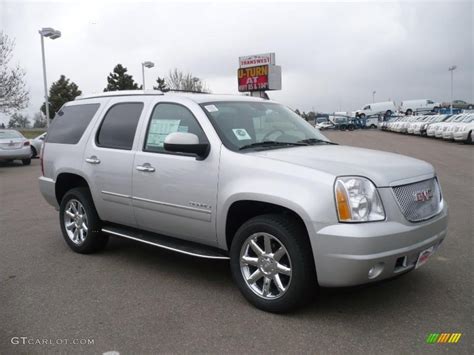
0 31 29 114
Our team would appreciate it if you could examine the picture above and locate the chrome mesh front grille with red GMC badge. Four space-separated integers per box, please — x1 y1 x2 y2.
393 178 441 222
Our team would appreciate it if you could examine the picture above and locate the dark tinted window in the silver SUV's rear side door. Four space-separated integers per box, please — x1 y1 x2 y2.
97 102 143 150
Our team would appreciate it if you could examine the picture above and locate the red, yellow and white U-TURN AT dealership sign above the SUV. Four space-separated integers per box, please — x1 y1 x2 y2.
237 53 281 92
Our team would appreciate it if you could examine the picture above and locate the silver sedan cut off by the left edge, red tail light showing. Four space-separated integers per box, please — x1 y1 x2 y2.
0 129 31 165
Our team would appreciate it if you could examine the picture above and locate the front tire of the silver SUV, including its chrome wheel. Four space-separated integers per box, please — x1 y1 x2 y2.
230 214 317 313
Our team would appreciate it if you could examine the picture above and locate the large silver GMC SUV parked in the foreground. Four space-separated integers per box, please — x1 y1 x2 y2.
39 91 447 312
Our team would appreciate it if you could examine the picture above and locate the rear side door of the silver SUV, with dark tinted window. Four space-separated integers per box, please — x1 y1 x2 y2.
83 99 144 226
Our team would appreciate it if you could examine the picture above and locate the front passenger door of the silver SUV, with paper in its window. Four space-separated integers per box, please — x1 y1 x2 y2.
132 102 219 245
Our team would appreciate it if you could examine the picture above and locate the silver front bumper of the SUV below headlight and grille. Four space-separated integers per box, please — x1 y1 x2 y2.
310 203 448 287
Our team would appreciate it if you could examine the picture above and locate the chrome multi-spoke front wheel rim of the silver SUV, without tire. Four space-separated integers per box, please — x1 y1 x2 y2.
240 232 291 300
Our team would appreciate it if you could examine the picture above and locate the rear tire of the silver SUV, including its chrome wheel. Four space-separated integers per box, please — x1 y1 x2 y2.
59 187 108 254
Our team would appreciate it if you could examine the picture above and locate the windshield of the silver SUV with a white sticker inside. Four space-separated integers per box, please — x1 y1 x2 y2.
201 101 329 151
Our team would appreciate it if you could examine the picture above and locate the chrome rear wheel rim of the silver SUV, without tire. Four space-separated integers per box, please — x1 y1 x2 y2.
64 199 89 245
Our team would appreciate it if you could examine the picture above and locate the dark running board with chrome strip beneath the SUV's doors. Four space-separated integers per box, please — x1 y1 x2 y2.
102 225 230 260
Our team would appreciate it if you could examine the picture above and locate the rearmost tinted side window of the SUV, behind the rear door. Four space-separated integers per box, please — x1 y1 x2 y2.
47 104 100 144
